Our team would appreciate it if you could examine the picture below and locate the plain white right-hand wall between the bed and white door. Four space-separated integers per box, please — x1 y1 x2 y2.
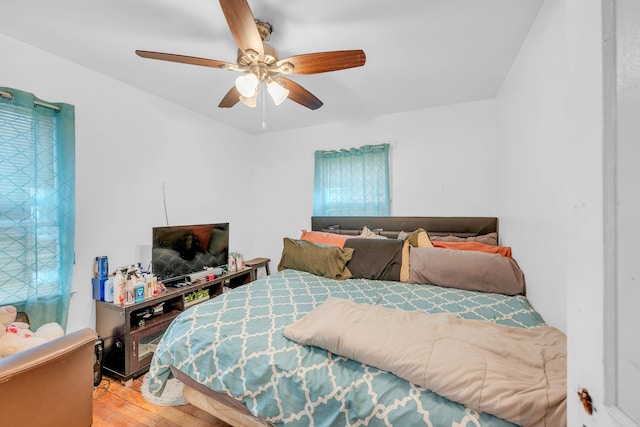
497 1 568 331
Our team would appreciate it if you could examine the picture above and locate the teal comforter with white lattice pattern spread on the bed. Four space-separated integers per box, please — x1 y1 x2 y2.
149 270 544 427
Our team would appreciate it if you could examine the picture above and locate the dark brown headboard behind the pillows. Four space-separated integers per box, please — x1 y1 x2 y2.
311 216 498 238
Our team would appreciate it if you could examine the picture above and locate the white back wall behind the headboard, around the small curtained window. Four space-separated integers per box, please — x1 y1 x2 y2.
251 100 497 265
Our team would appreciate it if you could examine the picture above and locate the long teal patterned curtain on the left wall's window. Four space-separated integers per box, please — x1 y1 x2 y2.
0 87 75 330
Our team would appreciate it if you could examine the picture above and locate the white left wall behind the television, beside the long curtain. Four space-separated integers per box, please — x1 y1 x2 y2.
0 35 257 331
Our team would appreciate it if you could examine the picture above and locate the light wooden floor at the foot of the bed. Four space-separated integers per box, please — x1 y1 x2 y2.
93 377 229 427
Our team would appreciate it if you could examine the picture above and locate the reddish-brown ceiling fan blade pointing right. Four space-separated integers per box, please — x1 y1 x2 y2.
277 50 367 74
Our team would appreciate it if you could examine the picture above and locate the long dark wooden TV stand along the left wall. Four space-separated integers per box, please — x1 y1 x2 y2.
96 258 269 381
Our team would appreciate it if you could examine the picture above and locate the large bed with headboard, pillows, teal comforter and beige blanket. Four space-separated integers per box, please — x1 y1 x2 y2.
149 217 566 427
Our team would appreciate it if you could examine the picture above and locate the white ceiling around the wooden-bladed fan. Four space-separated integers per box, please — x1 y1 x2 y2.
0 0 544 133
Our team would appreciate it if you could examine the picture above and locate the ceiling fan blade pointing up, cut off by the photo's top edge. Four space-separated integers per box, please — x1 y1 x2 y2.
220 0 264 60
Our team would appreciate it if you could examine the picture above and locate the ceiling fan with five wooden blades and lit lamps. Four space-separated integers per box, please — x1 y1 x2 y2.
136 0 366 110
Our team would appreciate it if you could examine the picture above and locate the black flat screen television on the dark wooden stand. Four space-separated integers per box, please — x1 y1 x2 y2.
151 222 229 283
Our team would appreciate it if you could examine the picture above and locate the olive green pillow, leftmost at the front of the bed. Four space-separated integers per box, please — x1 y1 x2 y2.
278 237 354 280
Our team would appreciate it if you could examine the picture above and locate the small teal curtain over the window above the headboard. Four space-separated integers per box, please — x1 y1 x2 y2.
313 144 391 216
